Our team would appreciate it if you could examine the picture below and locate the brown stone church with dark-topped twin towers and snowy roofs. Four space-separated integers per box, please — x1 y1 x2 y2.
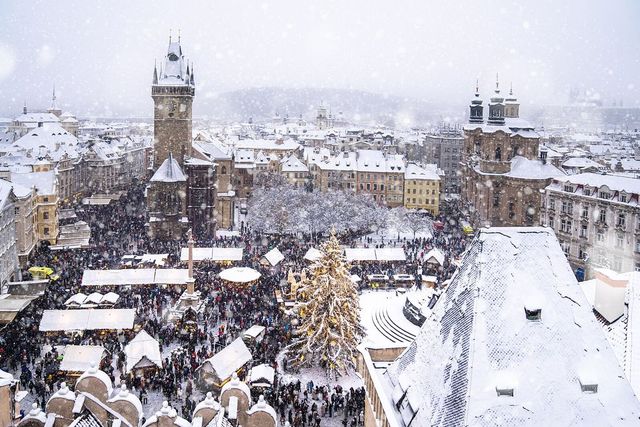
461 82 564 226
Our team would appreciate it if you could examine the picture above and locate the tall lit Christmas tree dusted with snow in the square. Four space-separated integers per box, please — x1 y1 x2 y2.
288 232 363 378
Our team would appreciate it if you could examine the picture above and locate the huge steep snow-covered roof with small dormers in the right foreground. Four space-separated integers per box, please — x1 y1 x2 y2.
380 227 640 427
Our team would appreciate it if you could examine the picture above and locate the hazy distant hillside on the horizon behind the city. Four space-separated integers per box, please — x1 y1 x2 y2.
195 87 460 125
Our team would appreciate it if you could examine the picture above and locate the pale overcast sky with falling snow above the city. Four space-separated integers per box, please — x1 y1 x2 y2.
0 0 640 116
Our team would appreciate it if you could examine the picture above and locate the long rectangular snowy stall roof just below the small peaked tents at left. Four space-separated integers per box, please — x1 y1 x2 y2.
40 309 136 332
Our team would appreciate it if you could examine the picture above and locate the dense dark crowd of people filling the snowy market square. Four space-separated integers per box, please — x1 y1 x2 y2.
0 187 465 427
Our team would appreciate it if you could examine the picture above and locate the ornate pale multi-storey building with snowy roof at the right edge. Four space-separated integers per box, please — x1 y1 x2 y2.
540 173 640 278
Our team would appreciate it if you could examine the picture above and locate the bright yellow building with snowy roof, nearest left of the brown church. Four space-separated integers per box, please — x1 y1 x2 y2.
404 163 440 215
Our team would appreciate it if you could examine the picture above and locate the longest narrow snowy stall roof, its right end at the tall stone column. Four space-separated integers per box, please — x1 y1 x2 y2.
81 268 189 286
